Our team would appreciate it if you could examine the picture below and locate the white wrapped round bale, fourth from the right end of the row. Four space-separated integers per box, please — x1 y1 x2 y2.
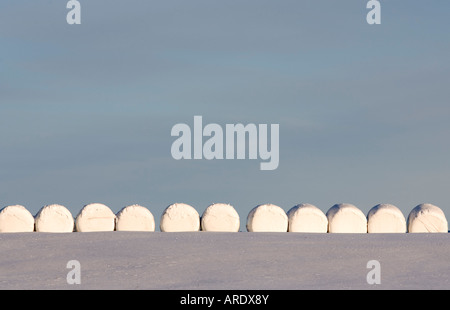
287 203 328 233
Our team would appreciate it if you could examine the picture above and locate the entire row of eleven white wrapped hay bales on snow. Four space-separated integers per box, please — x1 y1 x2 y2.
0 203 448 233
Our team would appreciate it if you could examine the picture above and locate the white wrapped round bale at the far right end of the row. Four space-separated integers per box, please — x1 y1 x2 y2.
408 203 448 233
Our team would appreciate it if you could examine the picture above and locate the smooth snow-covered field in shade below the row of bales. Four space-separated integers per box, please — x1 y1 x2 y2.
0 231 450 290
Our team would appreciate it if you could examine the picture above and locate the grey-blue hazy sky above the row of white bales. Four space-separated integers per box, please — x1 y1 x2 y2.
0 0 450 229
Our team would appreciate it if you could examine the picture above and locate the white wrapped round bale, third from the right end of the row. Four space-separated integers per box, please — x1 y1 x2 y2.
326 203 367 233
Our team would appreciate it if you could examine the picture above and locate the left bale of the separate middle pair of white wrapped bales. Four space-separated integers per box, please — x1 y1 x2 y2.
159 203 200 232
